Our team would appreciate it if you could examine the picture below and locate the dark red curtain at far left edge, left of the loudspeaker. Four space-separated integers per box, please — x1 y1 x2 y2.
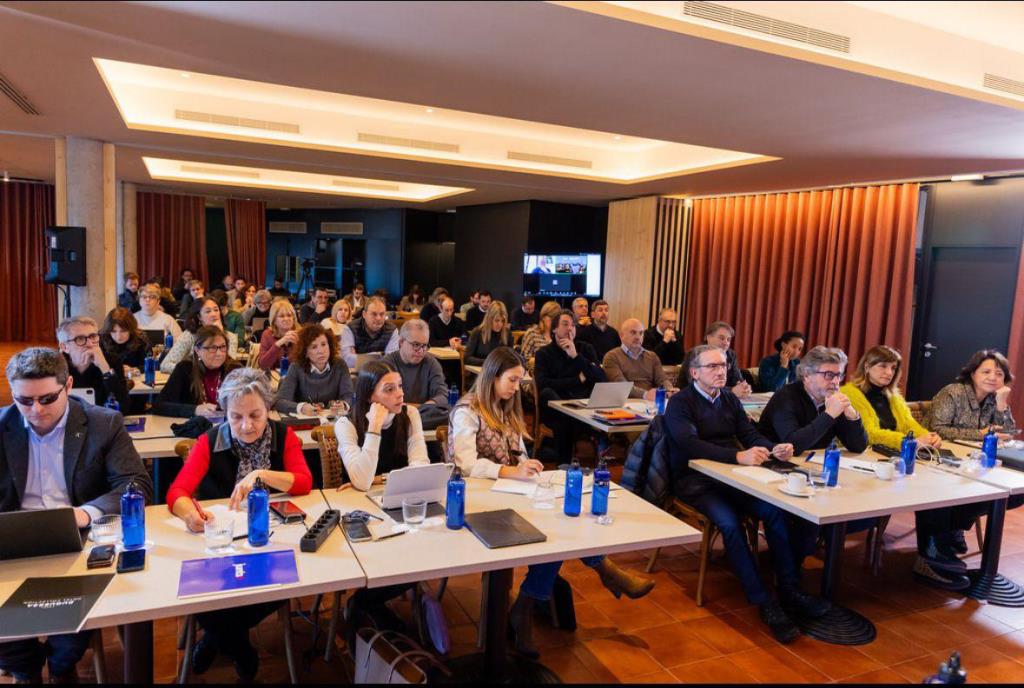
0 181 57 342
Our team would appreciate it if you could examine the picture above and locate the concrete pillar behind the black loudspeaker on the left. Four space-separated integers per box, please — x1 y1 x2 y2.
54 136 118 321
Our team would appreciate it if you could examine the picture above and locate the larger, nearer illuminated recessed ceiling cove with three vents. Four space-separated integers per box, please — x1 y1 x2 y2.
94 58 778 184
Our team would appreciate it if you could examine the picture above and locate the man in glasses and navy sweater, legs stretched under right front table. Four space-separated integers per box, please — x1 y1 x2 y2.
665 344 831 644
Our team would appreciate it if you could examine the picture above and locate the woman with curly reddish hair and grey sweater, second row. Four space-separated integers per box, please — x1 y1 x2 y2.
273 323 352 416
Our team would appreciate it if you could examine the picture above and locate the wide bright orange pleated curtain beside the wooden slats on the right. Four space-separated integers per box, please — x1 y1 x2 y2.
683 184 919 380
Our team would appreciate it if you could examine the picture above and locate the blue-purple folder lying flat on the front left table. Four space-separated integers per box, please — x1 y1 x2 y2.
178 550 299 597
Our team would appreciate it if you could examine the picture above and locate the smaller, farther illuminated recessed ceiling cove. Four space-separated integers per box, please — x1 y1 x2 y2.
142 157 473 203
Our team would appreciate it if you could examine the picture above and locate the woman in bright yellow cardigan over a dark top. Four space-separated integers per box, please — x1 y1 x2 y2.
840 344 942 449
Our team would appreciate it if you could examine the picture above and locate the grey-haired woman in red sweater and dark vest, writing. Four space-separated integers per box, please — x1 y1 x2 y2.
167 368 312 683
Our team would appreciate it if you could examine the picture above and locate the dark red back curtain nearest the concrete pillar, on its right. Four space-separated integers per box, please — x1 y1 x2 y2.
135 191 207 285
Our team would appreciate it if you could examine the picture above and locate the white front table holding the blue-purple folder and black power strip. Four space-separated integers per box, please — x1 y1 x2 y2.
0 490 367 684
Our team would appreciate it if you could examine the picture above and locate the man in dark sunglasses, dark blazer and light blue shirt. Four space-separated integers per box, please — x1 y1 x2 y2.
0 347 153 683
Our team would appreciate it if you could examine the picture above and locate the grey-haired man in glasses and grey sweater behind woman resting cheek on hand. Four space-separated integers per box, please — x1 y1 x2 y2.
384 318 449 430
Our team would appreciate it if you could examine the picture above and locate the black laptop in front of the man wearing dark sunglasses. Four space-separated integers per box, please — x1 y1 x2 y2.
0 507 83 561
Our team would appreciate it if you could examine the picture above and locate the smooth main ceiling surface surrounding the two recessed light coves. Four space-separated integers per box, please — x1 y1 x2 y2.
0 2 1024 210
